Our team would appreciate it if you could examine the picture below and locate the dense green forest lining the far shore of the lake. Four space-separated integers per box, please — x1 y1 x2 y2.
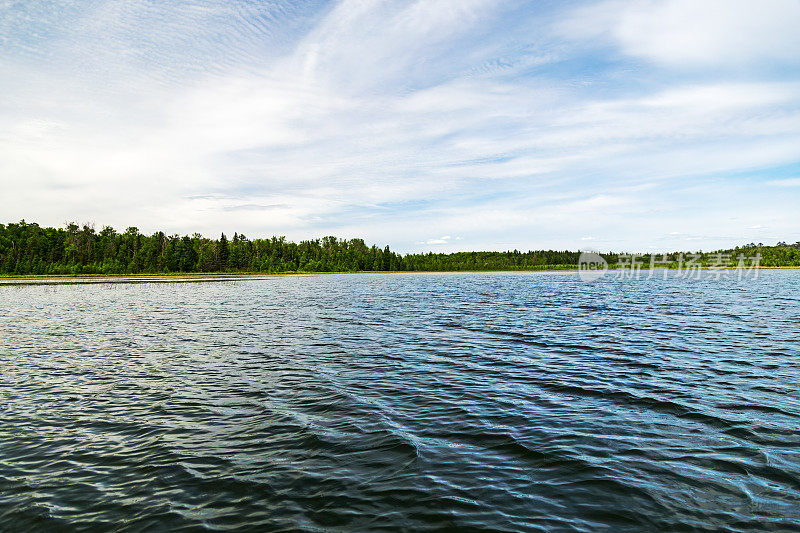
0 221 800 275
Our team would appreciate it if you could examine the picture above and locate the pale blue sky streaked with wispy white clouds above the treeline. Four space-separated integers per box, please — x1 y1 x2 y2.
0 0 800 252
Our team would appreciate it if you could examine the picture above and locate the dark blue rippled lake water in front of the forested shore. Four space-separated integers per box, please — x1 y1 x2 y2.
0 271 800 531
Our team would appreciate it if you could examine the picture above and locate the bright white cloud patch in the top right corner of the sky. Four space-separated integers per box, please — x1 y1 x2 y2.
559 0 800 68
